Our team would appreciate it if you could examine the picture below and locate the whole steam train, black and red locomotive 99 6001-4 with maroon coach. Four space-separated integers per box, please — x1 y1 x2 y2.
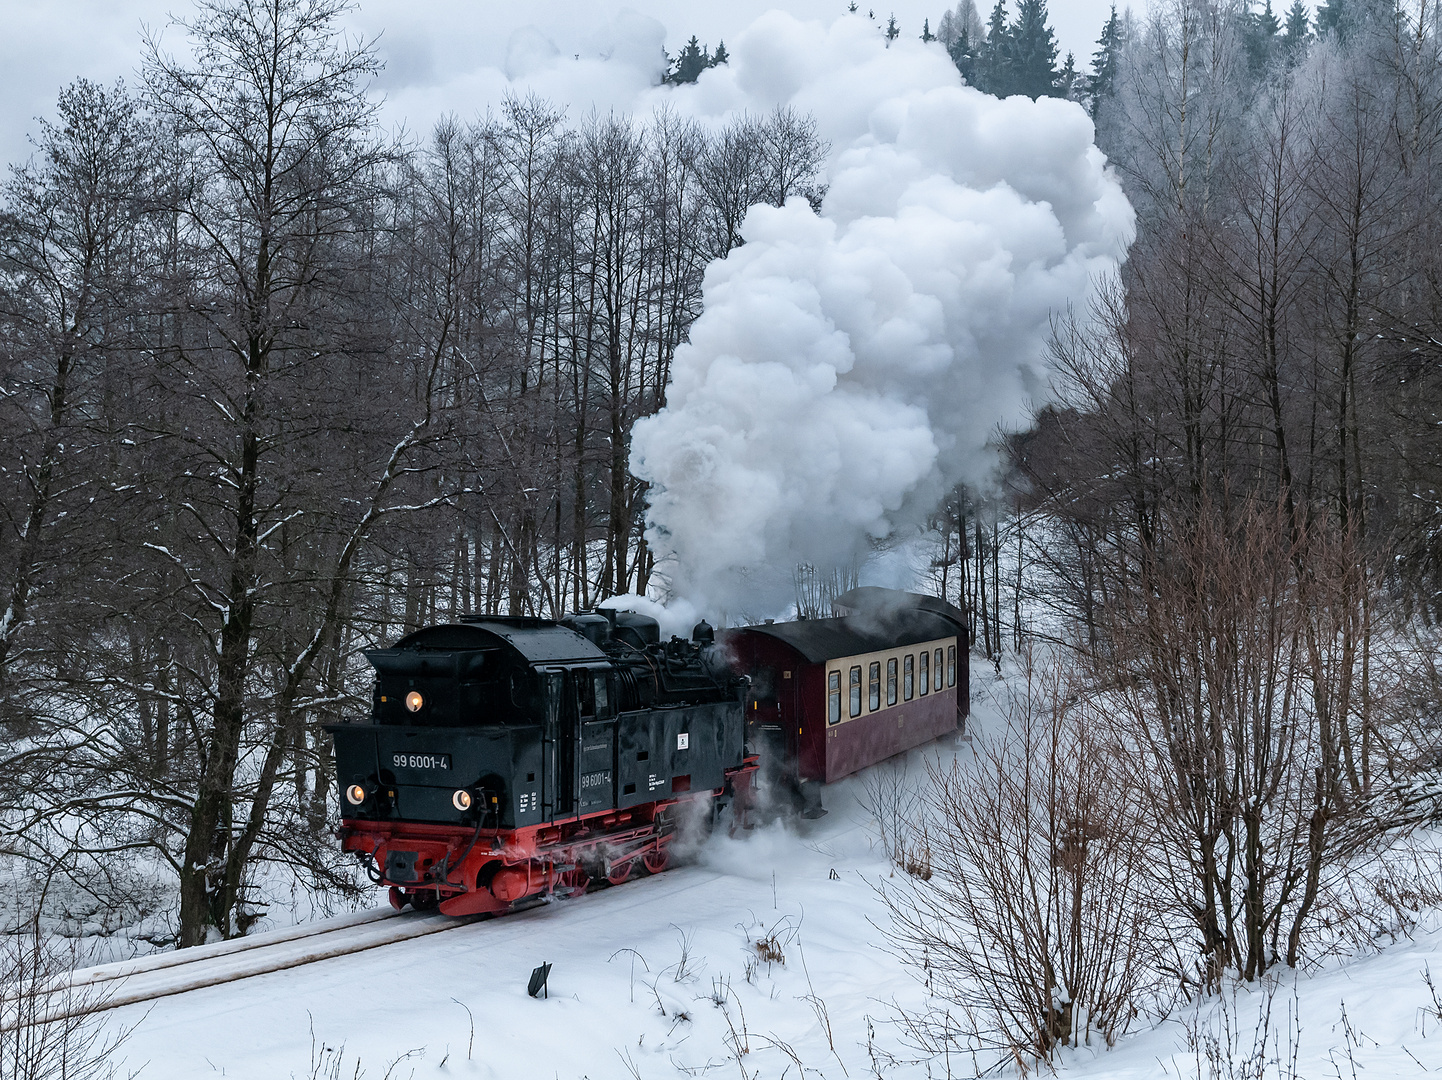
327 588 968 916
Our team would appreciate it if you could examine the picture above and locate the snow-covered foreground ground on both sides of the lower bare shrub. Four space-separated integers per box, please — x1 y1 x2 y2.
93 748 1442 1080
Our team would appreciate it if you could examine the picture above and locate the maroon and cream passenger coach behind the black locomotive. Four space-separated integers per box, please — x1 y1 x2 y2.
724 587 970 813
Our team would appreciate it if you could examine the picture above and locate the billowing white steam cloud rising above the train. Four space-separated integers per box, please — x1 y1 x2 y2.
632 12 1133 613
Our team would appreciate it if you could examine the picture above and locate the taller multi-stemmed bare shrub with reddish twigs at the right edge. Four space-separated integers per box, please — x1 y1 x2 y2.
1099 497 1436 989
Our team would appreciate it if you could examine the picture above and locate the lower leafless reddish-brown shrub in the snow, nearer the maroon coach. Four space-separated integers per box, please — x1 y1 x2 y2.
883 651 1156 1066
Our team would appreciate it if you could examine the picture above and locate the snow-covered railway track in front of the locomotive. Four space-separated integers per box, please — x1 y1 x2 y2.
29 907 482 1019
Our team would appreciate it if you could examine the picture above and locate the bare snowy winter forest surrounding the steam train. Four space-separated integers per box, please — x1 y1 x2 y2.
0 0 1442 1057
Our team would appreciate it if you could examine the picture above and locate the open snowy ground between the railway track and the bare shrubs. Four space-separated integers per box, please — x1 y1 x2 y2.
106 761 945 1080
